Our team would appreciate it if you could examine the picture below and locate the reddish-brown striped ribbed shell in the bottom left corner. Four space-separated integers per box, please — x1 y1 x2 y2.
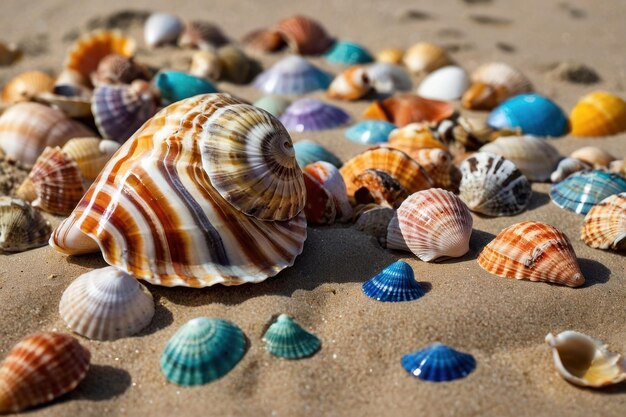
0 332 91 414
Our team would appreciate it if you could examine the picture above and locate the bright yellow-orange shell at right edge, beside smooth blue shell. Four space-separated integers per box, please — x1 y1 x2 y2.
570 91 626 136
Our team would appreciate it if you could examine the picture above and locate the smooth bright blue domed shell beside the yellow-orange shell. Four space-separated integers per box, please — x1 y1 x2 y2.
487 94 569 136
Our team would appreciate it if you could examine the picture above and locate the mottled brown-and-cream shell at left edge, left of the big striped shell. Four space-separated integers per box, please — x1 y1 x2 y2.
0 196 52 252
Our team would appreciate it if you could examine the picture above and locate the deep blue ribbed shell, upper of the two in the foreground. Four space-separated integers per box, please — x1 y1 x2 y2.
363 261 425 302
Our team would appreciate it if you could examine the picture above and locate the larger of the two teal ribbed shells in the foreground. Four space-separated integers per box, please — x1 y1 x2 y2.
161 317 246 386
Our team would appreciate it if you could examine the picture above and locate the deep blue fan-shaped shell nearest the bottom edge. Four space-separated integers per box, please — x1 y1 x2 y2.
402 343 476 382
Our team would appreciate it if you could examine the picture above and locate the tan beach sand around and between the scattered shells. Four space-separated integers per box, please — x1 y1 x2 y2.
0 0 626 417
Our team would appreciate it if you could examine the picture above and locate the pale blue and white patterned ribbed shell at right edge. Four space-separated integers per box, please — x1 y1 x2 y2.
550 170 626 214
